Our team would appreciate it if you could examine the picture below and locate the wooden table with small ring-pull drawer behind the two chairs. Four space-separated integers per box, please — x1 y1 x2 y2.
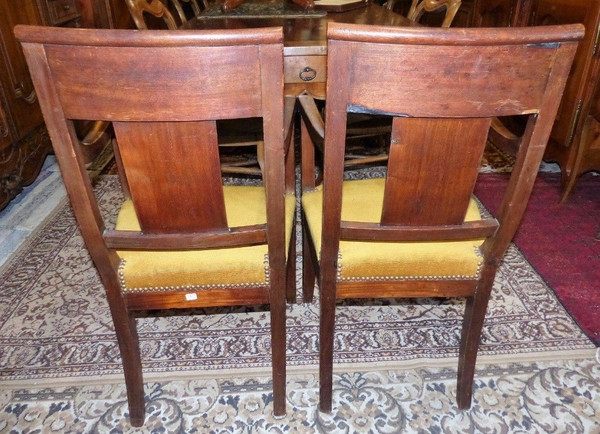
181 4 416 97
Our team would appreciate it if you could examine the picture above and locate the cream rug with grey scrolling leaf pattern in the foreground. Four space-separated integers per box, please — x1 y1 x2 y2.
0 360 600 434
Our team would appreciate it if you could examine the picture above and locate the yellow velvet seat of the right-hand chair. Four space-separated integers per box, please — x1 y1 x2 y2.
302 178 483 281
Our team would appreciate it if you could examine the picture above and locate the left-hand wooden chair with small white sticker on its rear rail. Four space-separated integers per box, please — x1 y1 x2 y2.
15 26 295 426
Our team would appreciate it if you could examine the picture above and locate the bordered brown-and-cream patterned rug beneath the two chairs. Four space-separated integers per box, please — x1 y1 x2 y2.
0 176 595 387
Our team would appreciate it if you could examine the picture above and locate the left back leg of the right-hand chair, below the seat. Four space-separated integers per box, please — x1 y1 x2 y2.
319 276 336 413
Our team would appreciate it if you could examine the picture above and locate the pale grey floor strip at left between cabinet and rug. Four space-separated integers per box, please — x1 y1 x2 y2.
0 155 66 266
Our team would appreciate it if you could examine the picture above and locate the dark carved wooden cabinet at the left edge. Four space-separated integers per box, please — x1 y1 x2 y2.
0 0 51 209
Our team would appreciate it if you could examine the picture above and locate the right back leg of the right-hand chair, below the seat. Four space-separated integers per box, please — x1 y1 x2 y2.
456 266 497 410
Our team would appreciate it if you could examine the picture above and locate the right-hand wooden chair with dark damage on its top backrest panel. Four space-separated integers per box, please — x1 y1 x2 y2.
300 23 583 412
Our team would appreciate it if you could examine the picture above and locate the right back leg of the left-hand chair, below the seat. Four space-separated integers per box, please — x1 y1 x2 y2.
270 268 286 416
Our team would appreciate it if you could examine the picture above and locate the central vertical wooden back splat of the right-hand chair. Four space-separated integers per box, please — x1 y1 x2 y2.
381 118 490 225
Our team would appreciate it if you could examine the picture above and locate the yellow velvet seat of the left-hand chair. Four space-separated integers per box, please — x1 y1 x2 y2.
116 186 296 292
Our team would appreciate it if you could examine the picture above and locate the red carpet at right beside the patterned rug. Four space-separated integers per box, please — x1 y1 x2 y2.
475 173 600 346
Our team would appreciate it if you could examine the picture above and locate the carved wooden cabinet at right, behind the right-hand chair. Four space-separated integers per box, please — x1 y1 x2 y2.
473 0 600 201
